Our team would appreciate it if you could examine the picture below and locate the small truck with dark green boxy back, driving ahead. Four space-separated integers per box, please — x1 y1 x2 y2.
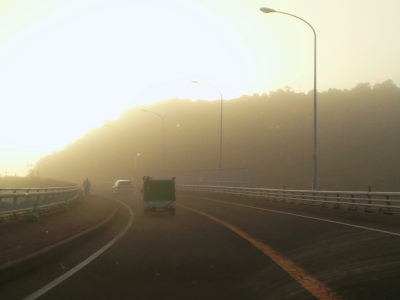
142 176 176 215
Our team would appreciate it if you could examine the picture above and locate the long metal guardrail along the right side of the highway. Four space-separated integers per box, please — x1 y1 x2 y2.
177 184 400 214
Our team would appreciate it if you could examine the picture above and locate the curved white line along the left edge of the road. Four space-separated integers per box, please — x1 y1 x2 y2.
22 201 133 300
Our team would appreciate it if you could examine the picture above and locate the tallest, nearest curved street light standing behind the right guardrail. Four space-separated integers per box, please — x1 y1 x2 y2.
260 7 318 190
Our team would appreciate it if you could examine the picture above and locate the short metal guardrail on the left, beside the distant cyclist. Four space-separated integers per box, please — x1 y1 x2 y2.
0 186 82 221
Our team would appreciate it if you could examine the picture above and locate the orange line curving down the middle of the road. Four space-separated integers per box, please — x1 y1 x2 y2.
179 204 339 300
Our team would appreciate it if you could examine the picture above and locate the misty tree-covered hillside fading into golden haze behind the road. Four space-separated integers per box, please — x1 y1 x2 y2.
36 81 400 191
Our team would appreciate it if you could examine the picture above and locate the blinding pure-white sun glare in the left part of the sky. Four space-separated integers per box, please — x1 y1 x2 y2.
0 1 266 175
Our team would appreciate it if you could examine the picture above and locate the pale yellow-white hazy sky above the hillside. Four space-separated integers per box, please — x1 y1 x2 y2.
0 0 400 175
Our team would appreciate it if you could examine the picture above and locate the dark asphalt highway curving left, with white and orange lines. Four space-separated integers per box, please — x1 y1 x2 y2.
0 194 400 299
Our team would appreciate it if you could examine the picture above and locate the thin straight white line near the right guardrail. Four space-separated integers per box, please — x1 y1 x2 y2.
194 197 400 236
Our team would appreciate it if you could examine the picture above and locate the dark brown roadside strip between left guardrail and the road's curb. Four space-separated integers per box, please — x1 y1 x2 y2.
0 196 115 278
